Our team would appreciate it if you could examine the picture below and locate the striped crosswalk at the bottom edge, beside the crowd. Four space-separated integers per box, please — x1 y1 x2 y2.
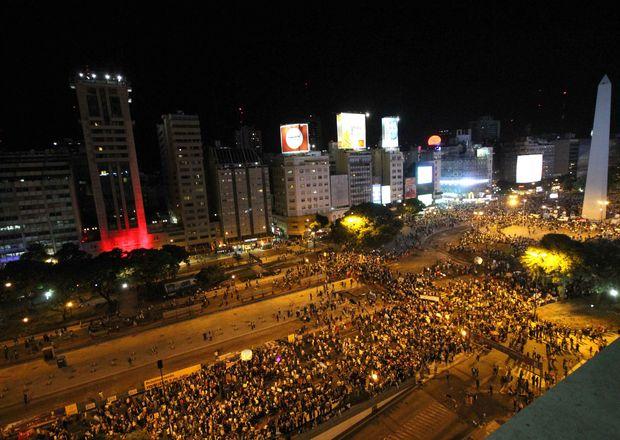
383 401 458 440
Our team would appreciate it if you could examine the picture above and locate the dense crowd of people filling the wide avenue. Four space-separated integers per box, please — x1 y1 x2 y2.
12 200 616 439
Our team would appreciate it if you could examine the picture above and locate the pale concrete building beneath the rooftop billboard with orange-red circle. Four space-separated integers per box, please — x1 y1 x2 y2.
270 152 331 236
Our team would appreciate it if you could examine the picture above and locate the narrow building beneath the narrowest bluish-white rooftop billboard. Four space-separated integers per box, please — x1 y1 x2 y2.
372 148 404 204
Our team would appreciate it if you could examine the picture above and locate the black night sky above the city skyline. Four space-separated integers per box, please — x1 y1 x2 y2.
0 1 620 169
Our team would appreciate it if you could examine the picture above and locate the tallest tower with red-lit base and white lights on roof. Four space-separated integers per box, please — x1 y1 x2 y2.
72 72 153 251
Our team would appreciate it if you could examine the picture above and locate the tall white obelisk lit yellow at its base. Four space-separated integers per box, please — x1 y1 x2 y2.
581 75 611 220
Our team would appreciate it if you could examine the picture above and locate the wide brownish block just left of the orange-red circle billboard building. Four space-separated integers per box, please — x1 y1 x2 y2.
207 148 271 244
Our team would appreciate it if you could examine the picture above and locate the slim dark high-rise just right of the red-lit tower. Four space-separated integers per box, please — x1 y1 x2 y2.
157 113 216 251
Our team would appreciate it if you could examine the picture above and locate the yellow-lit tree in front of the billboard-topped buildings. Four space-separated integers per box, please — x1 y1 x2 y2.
331 203 402 248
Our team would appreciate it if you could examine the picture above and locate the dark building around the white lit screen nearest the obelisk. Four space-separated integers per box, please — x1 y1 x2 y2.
501 136 555 183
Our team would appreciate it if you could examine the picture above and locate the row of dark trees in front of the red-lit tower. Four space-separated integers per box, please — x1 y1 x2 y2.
0 243 189 316
